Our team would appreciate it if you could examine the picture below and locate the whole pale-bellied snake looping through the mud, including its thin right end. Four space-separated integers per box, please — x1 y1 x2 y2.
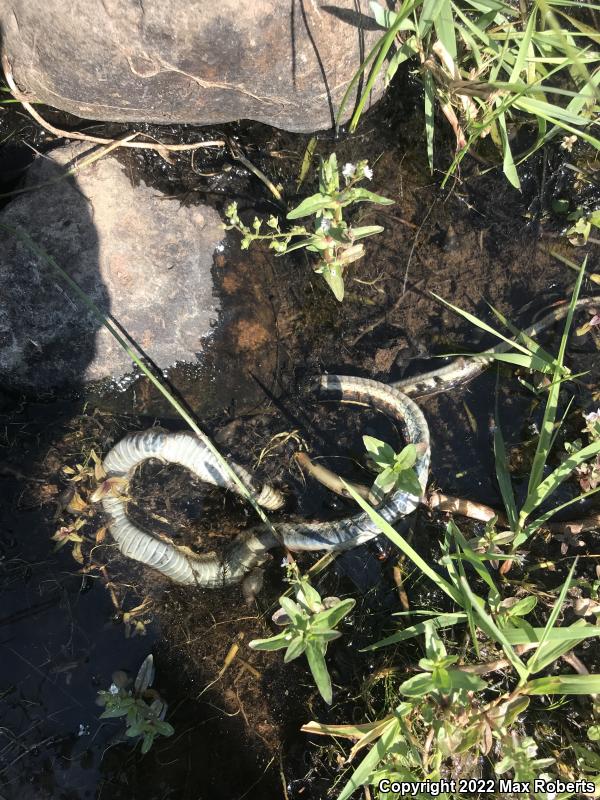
101 297 598 589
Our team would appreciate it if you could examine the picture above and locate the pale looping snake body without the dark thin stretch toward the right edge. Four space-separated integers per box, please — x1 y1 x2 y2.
102 375 430 588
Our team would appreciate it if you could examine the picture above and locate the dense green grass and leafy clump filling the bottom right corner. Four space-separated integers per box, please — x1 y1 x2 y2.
302 504 600 800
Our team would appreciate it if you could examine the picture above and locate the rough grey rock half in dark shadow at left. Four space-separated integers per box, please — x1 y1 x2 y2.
0 144 223 391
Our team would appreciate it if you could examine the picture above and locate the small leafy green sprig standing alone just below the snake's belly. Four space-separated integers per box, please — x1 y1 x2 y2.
250 564 355 704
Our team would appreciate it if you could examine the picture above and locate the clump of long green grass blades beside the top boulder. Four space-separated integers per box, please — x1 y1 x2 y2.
338 0 600 188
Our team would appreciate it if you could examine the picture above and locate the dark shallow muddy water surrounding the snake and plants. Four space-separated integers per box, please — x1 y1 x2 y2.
0 81 599 800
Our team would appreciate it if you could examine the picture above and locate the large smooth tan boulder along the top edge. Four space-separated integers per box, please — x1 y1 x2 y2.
0 0 383 132
